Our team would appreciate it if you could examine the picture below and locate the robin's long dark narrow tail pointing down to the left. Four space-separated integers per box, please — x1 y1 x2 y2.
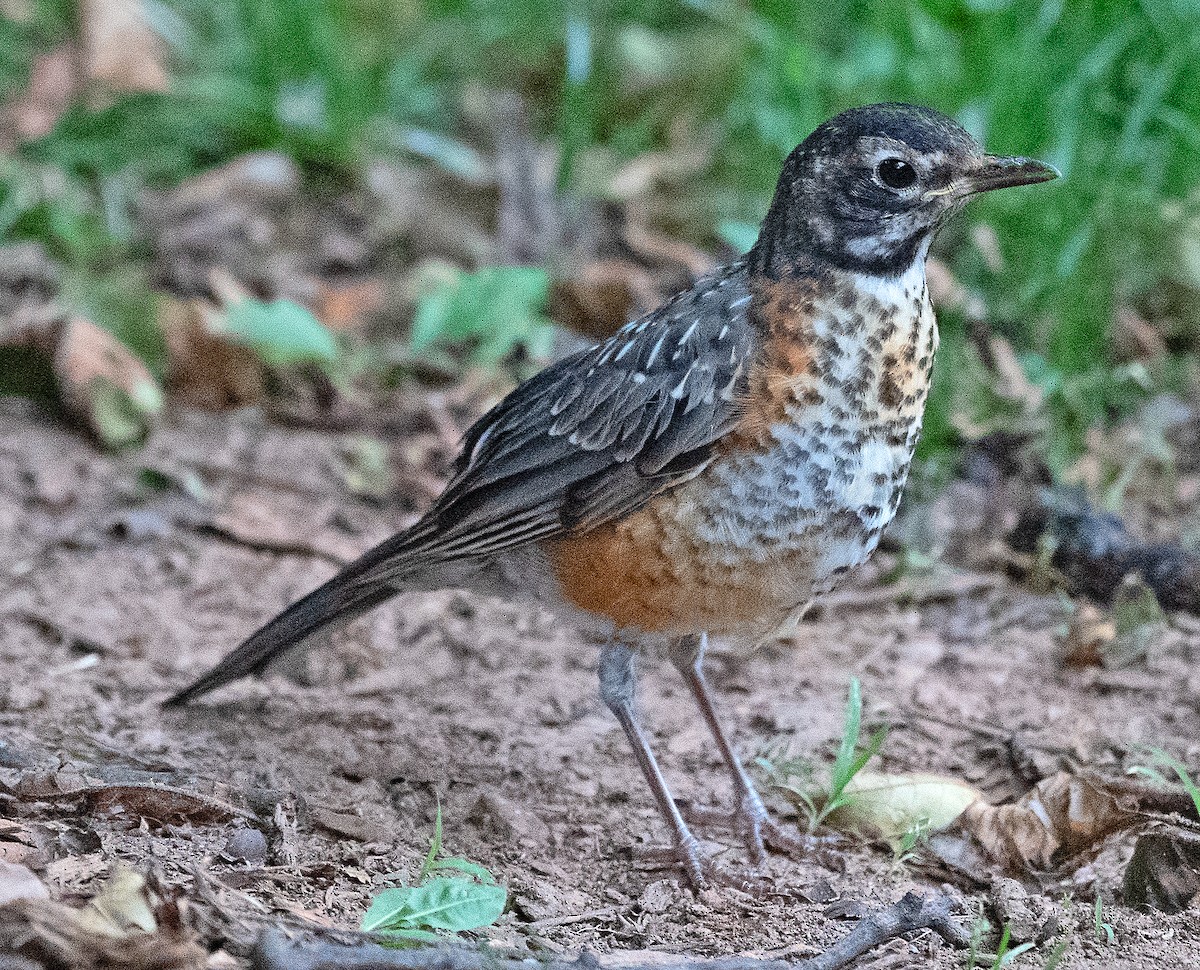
162 529 436 707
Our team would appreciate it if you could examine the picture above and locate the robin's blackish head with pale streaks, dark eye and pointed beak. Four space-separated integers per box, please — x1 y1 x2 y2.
752 104 1058 275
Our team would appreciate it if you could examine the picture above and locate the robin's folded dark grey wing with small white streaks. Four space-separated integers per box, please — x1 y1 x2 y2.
350 265 756 583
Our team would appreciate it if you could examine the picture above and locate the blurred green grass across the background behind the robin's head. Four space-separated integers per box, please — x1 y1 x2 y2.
0 0 1200 468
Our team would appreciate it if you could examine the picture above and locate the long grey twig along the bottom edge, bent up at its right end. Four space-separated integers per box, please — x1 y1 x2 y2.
252 892 971 970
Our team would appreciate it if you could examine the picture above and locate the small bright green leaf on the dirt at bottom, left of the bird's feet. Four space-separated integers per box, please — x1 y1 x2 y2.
362 876 508 933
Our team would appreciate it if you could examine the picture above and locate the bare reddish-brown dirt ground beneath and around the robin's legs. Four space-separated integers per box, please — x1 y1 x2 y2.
0 391 1200 970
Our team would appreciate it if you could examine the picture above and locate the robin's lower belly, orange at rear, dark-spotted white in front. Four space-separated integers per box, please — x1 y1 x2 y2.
545 417 908 635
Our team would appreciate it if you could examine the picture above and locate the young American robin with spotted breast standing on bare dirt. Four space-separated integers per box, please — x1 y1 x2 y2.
167 104 1058 885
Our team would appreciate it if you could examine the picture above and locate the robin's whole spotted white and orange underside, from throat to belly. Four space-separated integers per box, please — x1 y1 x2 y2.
545 253 937 635
